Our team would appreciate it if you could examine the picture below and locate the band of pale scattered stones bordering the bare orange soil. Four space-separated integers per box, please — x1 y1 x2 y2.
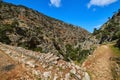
0 44 89 80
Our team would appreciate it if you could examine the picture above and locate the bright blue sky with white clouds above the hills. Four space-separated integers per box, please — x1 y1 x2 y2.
4 0 120 32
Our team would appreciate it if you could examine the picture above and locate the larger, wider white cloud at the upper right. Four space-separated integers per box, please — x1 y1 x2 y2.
87 0 117 8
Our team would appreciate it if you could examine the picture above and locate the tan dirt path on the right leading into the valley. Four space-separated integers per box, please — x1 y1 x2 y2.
82 45 113 80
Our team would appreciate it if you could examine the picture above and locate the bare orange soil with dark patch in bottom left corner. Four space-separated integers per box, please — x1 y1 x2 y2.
0 50 32 80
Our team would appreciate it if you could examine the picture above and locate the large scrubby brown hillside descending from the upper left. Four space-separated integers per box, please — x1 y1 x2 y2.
0 2 97 60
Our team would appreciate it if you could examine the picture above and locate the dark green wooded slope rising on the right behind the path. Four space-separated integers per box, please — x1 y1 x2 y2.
93 10 120 48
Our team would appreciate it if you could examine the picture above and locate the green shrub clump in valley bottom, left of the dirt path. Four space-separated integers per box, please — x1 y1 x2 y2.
65 44 90 62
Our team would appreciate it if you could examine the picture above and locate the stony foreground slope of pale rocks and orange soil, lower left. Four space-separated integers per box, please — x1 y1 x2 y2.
0 43 90 80
